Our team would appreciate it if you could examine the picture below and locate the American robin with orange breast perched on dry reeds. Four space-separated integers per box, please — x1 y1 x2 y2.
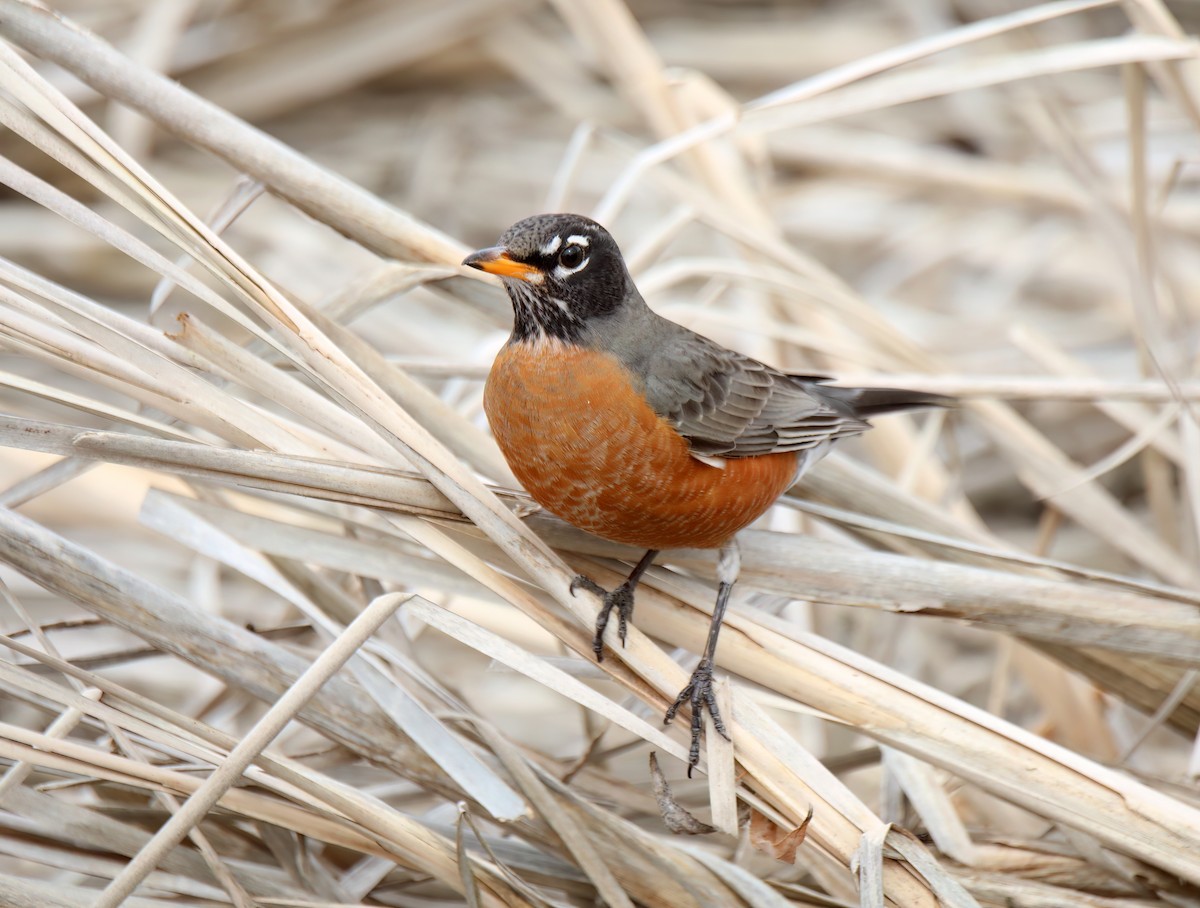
463 215 947 774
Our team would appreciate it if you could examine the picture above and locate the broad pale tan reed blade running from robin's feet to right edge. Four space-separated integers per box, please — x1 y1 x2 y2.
609 563 1200 880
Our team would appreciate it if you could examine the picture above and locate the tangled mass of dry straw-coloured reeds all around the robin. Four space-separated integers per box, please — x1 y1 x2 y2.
0 0 1200 908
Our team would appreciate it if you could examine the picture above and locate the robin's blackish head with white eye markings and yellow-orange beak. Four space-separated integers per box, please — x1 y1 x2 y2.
462 215 641 341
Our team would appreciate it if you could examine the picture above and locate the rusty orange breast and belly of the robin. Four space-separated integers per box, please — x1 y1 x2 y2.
484 341 797 548
